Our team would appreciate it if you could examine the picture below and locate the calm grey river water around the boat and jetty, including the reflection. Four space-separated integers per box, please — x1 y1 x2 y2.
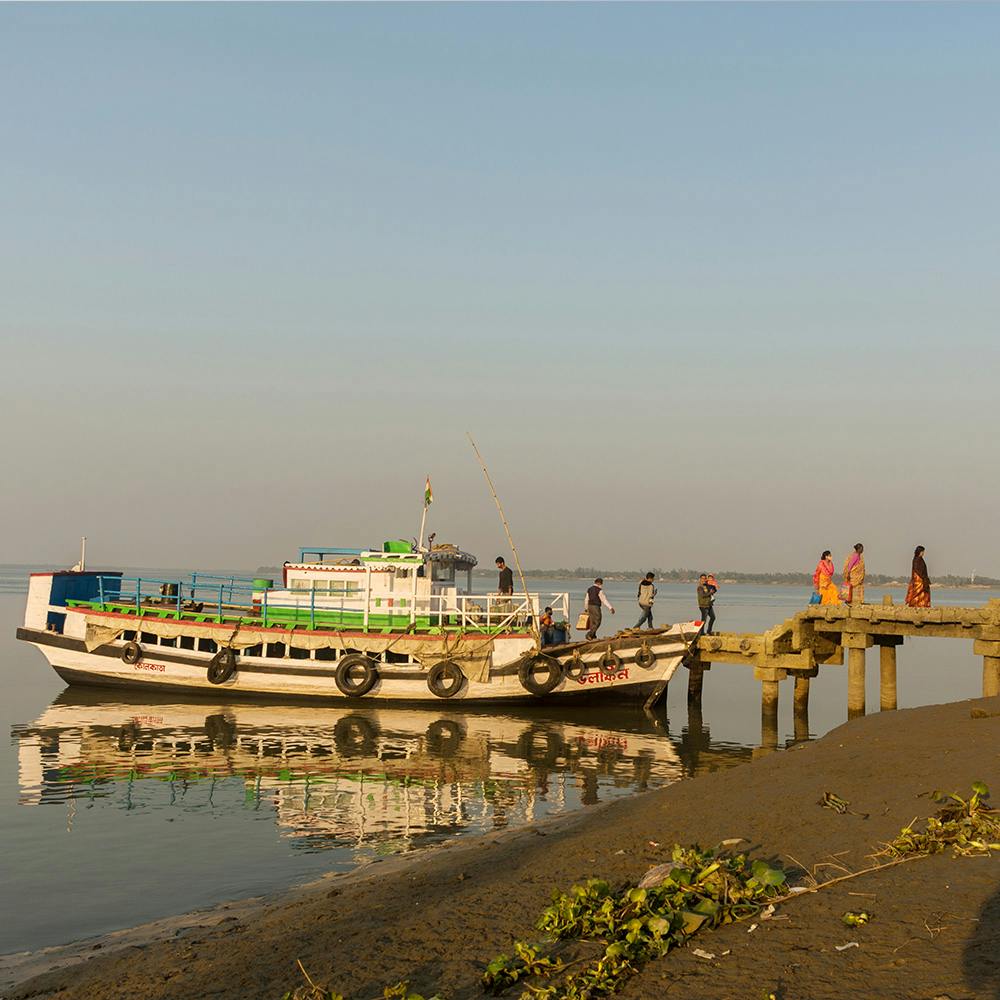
0 570 994 953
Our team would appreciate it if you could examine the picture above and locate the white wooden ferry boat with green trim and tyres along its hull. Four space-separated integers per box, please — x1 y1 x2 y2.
17 542 700 702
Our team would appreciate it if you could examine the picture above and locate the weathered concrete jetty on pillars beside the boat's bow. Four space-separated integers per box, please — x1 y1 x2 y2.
686 596 1000 747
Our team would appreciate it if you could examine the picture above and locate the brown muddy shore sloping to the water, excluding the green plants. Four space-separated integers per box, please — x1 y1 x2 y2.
4 698 1000 1000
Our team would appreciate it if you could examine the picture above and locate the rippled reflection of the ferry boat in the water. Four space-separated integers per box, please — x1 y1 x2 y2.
13 689 749 854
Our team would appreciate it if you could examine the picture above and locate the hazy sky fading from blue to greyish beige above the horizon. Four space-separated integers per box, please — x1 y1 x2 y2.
0 4 1000 575
